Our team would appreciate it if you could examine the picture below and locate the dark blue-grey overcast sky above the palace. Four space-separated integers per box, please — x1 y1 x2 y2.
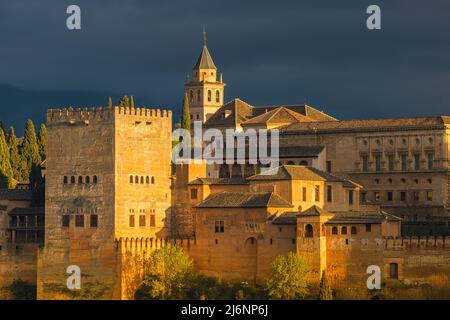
0 0 450 132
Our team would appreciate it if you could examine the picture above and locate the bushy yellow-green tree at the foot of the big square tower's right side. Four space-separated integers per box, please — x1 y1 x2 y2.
135 245 195 300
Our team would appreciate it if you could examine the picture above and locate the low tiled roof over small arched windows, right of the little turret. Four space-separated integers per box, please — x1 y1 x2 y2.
326 211 402 224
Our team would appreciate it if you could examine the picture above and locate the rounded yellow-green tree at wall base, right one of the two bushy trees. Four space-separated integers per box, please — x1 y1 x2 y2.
266 252 309 300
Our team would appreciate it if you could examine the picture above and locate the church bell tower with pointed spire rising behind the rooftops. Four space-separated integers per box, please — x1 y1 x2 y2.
184 31 225 123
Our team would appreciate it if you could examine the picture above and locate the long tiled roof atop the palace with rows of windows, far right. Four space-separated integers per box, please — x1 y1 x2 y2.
280 116 450 134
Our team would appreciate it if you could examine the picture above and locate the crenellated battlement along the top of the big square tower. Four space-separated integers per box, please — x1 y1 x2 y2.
47 106 172 125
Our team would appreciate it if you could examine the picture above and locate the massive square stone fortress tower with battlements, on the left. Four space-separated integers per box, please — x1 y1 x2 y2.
37 107 172 299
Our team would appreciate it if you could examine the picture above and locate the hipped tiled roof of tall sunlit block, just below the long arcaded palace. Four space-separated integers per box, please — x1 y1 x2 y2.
247 165 359 188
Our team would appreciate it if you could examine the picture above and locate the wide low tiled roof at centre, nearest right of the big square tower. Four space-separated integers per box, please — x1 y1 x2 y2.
196 192 293 208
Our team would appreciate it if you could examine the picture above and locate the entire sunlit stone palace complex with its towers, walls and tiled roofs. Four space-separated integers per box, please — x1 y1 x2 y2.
0 37 450 299
